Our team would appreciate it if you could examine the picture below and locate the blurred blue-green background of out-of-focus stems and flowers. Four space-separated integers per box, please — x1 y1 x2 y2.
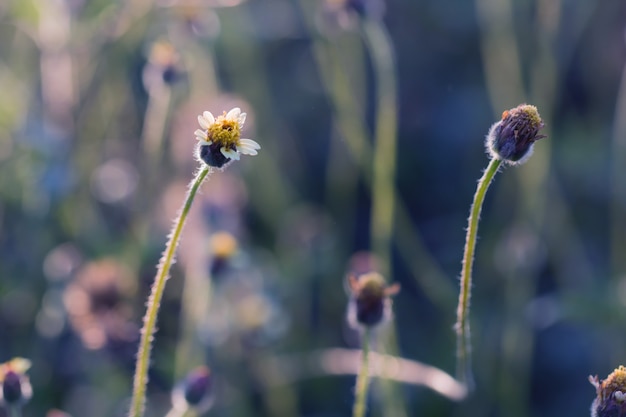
0 0 626 417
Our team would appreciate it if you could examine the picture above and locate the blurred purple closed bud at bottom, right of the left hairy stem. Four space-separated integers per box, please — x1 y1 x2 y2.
172 366 213 413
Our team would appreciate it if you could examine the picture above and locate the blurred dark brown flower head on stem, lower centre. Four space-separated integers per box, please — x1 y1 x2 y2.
348 272 400 328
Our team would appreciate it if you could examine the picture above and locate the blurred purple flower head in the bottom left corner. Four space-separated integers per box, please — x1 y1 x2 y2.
0 358 33 407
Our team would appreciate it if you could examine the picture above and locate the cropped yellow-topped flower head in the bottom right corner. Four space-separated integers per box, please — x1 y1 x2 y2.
589 366 626 417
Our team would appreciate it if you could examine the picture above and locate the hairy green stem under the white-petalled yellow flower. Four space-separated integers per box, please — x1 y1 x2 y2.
128 165 211 417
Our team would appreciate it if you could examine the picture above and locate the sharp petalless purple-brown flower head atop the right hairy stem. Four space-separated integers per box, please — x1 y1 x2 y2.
486 104 546 165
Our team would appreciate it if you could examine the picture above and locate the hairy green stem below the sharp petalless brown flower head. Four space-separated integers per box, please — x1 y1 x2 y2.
455 158 502 390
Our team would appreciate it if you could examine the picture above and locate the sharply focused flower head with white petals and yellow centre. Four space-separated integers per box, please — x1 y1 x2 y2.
195 107 261 168
